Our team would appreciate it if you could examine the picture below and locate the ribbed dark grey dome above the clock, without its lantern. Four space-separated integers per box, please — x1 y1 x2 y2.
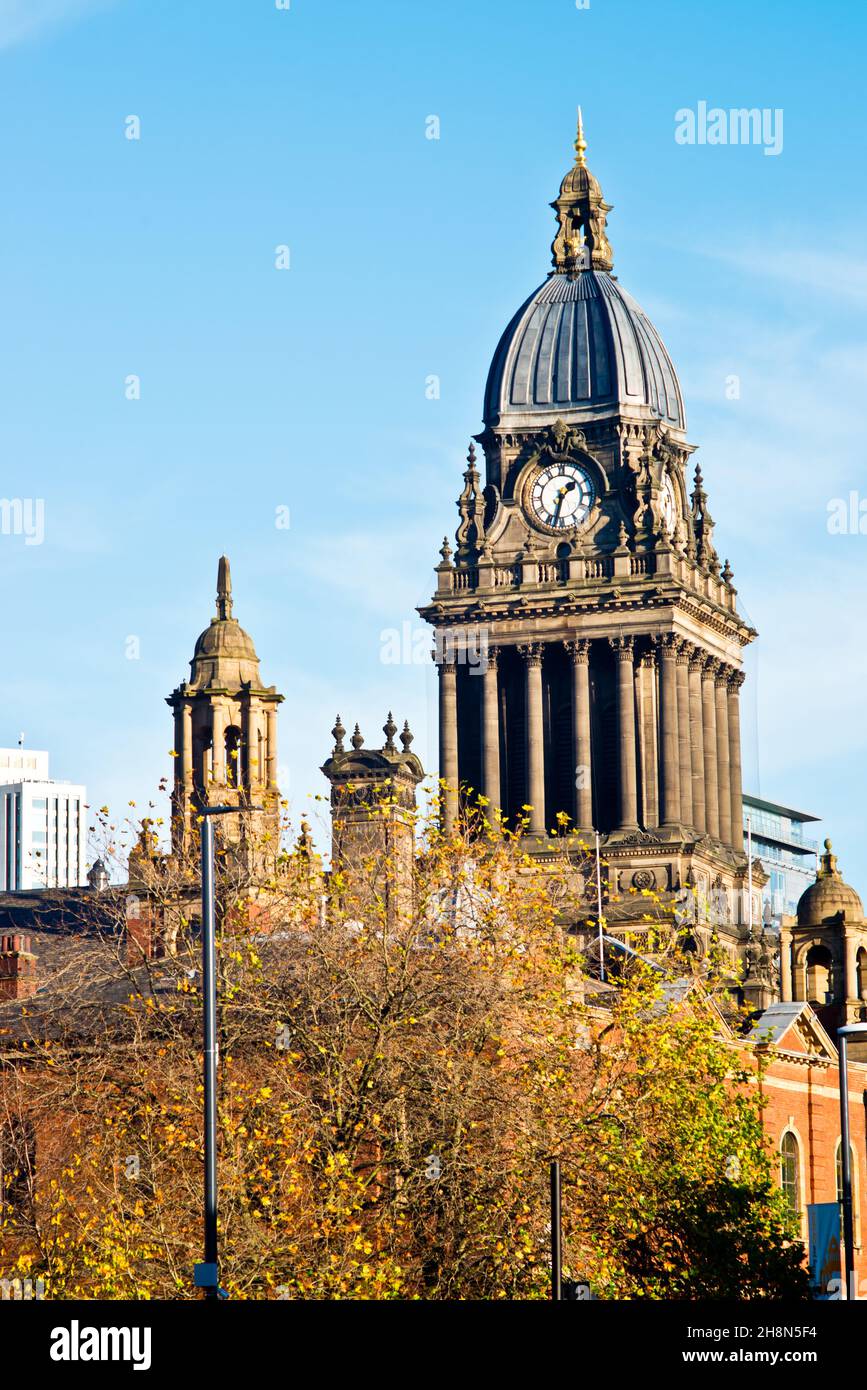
485 270 686 430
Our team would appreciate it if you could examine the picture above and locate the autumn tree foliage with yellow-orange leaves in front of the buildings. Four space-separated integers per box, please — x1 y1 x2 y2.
0 801 806 1298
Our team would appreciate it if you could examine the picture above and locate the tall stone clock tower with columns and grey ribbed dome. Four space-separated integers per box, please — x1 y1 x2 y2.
421 118 756 948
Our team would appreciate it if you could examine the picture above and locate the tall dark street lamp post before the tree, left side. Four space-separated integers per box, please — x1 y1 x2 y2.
193 806 258 1298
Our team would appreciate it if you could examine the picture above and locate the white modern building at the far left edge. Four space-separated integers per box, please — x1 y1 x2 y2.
0 748 88 892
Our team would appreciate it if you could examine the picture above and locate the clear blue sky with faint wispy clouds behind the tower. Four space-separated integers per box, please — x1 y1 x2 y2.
0 0 867 890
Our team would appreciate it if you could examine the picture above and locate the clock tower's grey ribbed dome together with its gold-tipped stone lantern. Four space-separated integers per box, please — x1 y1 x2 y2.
485 108 686 430
